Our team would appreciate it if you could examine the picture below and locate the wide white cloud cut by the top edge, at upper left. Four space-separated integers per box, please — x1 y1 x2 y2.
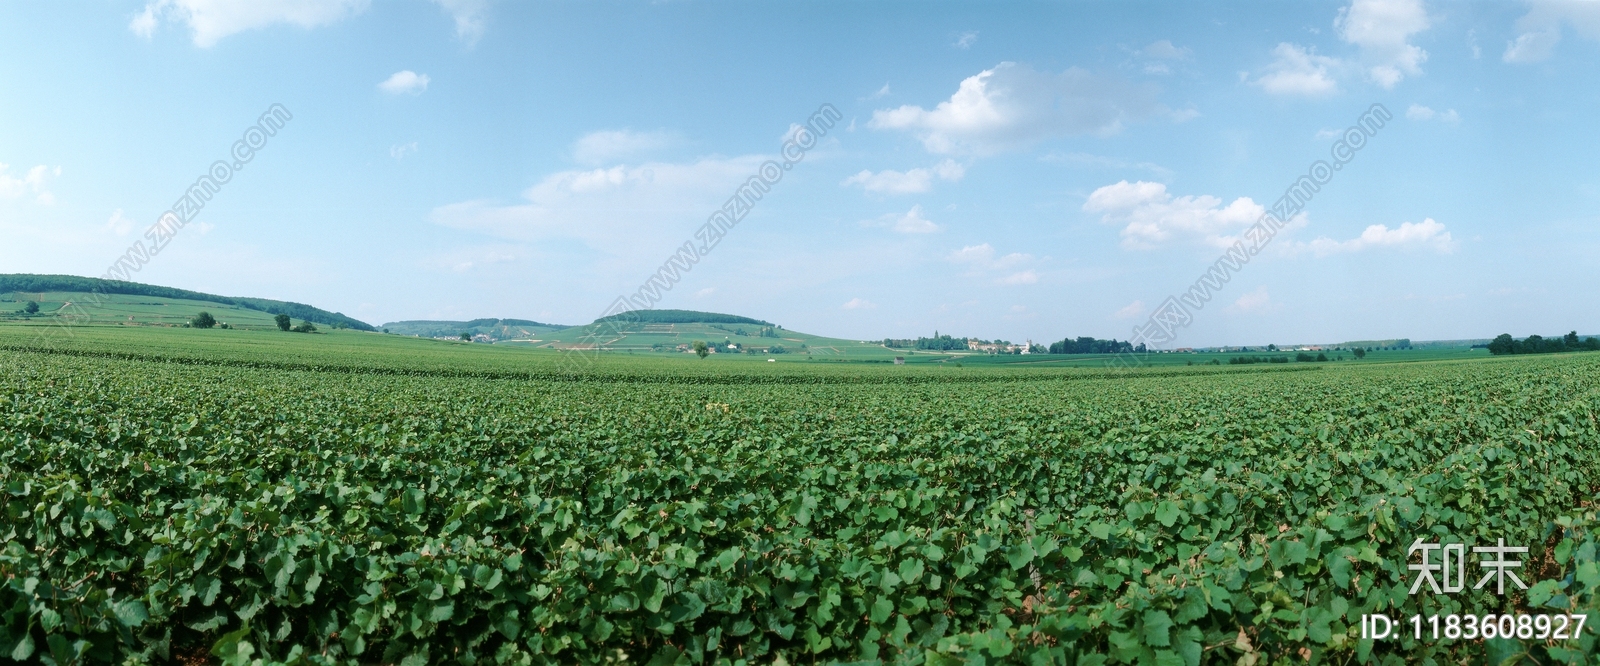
128 0 370 48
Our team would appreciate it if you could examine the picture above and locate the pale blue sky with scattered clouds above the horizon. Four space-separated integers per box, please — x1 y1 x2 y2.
0 0 1600 346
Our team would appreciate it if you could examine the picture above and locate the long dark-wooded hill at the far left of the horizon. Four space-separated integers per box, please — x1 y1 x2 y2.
0 274 374 331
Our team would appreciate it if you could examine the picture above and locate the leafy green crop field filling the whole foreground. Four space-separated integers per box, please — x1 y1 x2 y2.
0 325 1600 666
